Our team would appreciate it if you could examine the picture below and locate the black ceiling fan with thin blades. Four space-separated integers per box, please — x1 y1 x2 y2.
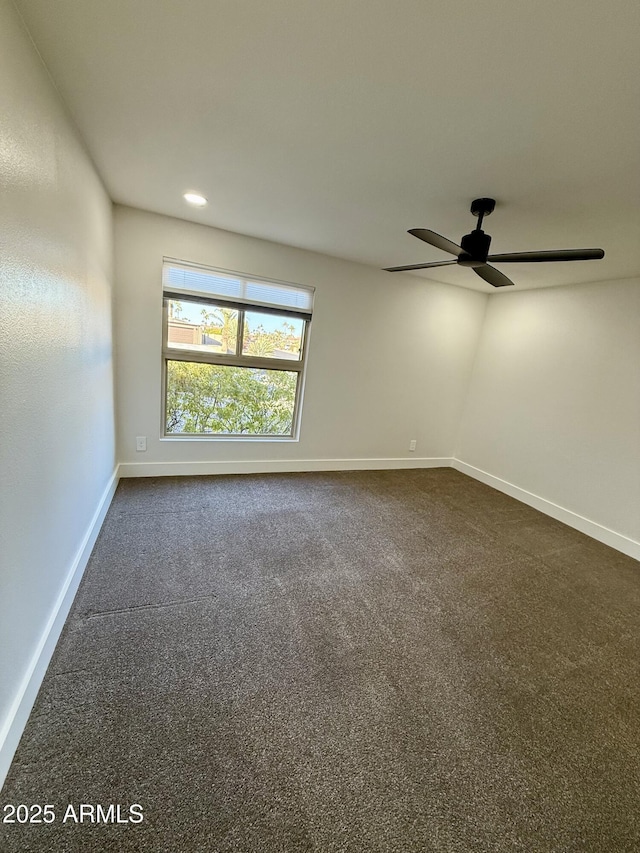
385 198 604 287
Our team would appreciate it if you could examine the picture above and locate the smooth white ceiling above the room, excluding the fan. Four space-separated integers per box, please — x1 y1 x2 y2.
16 0 640 292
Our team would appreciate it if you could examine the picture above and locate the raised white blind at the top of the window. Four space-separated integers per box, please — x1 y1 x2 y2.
162 259 314 315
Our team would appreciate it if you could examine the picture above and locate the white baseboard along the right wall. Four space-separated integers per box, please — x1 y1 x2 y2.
451 458 640 560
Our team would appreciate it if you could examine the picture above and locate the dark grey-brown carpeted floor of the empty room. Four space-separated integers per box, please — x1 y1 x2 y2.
0 469 640 853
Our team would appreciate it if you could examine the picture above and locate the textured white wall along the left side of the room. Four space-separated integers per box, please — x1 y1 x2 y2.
0 0 115 782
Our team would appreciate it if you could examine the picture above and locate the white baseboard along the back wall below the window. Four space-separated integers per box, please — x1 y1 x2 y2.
119 456 451 477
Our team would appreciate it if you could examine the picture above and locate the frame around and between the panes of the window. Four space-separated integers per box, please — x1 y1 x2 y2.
160 258 314 441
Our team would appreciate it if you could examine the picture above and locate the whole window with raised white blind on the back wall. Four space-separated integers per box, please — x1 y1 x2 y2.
162 259 313 438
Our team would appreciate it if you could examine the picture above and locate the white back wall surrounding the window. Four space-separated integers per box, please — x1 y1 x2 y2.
115 207 487 475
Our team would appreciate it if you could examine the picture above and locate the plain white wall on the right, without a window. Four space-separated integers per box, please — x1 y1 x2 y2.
456 279 640 555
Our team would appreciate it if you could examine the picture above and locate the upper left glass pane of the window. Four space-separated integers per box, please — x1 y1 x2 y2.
167 299 238 355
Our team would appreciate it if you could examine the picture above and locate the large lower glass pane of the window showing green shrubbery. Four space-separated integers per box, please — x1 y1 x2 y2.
166 361 298 435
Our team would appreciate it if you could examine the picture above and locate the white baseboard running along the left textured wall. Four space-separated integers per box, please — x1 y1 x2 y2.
0 467 119 788
